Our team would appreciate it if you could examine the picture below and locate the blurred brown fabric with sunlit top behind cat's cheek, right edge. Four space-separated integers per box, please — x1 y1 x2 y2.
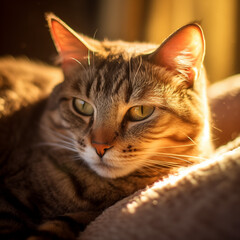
208 74 240 147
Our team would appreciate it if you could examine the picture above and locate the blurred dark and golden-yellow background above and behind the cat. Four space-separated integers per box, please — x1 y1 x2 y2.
0 0 240 82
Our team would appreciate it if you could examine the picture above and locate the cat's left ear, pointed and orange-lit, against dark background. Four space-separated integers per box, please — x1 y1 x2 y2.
46 13 92 68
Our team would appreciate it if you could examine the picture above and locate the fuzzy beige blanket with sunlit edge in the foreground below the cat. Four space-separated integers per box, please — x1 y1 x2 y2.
79 138 240 240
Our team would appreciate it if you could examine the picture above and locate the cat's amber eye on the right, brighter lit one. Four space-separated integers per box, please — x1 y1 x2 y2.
128 105 154 121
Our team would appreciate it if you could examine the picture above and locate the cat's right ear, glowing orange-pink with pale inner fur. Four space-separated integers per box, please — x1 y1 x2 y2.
150 24 205 86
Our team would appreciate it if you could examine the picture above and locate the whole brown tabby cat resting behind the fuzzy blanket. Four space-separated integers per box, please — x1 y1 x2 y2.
0 13 211 240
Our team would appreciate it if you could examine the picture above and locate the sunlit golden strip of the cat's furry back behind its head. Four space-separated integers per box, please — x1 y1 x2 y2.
0 57 63 118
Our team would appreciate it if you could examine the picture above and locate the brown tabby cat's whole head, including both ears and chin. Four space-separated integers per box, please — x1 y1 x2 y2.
42 14 208 178
